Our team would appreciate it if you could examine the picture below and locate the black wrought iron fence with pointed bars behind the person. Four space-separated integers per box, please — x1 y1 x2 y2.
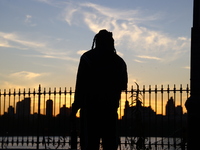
0 85 190 150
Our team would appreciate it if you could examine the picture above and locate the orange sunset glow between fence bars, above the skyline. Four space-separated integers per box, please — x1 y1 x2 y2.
0 85 190 119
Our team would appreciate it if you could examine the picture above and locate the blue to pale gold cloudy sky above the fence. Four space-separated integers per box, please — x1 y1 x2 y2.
0 0 193 89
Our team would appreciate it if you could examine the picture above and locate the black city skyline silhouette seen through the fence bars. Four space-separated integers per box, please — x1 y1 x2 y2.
0 97 186 137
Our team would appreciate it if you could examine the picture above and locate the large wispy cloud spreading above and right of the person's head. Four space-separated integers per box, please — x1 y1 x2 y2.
59 2 190 62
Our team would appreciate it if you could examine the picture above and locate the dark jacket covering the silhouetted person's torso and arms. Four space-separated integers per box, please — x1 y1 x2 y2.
72 49 128 114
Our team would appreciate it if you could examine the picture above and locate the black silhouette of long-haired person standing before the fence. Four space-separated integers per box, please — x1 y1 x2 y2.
71 30 128 150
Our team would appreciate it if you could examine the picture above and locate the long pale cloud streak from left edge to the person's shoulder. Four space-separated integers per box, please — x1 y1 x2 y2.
0 32 78 61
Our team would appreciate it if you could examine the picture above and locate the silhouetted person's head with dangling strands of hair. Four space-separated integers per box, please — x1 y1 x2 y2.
92 29 115 52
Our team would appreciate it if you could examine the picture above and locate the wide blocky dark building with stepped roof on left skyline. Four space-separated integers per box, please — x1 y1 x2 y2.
16 97 31 117
